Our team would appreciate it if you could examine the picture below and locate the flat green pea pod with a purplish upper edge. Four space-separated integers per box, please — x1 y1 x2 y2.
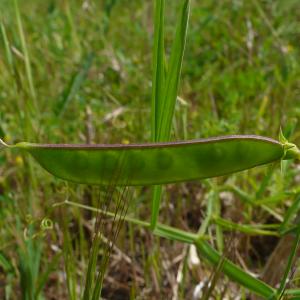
1 135 299 186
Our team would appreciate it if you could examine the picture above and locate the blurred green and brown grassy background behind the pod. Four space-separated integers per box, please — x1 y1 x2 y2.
0 0 300 299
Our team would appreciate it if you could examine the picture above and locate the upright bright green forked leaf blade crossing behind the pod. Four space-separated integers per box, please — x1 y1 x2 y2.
151 0 190 230
